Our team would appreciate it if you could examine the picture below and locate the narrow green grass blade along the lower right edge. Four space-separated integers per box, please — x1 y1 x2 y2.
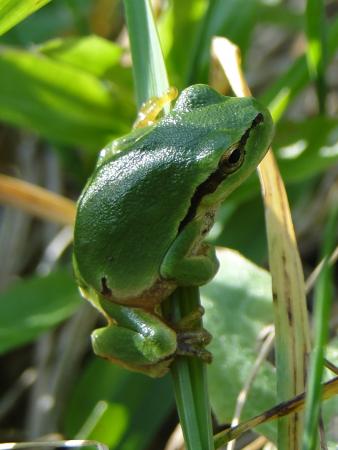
302 206 338 450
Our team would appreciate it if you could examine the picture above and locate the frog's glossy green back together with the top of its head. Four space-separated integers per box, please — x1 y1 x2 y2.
74 94 268 305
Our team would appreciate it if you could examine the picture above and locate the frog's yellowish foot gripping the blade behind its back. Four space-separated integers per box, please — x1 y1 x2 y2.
133 87 177 128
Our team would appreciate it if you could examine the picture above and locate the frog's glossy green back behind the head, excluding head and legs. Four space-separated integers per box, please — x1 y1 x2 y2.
74 121 213 304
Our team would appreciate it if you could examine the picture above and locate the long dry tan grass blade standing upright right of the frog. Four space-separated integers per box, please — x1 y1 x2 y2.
212 38 310 450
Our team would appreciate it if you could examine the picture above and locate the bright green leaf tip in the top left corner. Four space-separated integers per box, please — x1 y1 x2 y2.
0 0 51 35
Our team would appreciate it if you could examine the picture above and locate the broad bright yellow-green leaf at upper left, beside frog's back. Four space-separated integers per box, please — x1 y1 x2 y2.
0 47 133 150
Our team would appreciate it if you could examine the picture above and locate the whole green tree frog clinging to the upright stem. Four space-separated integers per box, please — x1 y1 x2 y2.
74 85 273 376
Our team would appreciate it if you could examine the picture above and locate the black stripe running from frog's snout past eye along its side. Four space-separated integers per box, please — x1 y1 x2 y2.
178 113 264 233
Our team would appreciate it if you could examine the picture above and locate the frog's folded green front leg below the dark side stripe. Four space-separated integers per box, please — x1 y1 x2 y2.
161 219 219 286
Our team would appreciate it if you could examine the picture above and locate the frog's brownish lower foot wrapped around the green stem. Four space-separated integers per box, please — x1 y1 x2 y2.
175 306 212 363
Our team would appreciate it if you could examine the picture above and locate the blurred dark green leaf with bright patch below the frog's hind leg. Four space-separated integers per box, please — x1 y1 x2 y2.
64 357 174 450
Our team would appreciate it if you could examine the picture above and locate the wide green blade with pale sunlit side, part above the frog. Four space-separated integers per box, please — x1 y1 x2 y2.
124 0 169 107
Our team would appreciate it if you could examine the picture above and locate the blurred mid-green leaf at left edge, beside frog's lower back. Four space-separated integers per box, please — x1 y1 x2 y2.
0 270 81 354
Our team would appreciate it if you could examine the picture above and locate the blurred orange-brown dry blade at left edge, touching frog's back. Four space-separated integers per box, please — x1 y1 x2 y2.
0 175 76 225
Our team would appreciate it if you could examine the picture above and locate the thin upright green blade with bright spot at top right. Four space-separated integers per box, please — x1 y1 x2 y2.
305 0 326 114
